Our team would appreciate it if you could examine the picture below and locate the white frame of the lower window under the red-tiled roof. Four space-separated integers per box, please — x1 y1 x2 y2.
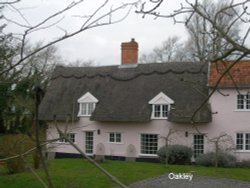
235 131 250 152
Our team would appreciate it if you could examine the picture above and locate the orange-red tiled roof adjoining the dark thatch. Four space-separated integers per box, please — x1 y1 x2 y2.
209 60 250 88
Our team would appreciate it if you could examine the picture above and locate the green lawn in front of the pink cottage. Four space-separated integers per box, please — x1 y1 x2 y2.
0 159 250 188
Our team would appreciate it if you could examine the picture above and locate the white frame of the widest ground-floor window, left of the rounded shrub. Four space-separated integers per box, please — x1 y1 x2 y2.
140 133 159 157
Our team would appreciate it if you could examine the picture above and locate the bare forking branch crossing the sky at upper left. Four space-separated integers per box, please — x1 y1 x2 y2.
0 0 137 74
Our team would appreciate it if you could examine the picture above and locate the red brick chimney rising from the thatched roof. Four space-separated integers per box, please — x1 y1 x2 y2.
121 38 138 65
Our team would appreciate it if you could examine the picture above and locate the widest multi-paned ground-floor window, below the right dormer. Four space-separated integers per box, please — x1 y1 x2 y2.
141 134 158 155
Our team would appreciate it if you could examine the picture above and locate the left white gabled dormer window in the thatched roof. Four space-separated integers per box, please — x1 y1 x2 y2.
77 92 98 116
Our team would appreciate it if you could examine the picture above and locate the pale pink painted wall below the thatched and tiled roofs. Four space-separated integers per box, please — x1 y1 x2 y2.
47 89 250 160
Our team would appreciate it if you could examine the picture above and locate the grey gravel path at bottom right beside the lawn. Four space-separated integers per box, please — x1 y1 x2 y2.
129 174 250 188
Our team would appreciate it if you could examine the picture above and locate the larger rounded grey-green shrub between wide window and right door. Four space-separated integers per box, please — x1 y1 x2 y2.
157 145 193 164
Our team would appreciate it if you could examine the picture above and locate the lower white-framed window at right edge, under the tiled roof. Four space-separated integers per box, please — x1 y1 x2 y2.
236 133 250 151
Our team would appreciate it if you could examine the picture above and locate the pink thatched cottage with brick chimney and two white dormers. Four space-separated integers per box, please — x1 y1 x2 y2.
39 39 250 160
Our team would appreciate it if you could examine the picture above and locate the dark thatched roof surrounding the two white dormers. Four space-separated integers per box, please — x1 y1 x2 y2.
39 62 211 123
